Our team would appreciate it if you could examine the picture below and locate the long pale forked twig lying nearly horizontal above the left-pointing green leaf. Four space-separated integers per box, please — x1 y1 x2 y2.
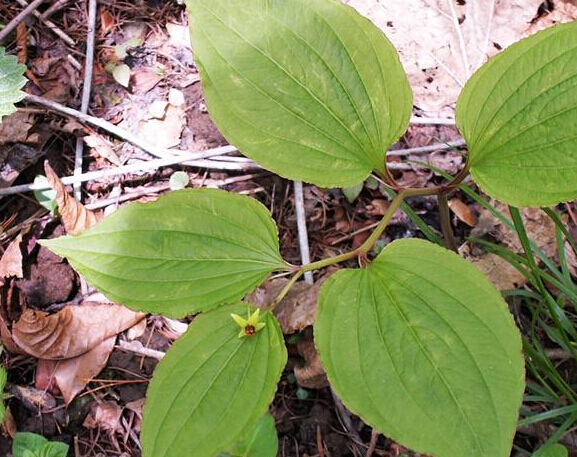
0 146 243 196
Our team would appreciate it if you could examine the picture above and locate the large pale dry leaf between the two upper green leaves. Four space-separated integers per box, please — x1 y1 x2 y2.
344 0 542 116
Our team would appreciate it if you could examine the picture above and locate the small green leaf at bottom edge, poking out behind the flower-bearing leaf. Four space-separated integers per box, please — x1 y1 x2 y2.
219 413 278 457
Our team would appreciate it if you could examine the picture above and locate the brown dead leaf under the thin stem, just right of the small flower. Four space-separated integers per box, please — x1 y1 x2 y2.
246 276 326 335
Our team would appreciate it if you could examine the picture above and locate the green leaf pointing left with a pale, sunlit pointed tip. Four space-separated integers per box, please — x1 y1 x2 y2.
42 189 286 316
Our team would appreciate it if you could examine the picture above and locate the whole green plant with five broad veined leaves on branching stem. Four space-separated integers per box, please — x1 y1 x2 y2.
43 0 577 457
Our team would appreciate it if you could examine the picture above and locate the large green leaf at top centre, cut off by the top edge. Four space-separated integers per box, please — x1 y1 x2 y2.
186 0 412 187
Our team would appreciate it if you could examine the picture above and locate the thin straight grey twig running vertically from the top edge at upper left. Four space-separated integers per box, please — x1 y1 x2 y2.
74 0 96 201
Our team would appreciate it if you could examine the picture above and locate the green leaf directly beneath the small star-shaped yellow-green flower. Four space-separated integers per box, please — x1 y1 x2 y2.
142 303 287 457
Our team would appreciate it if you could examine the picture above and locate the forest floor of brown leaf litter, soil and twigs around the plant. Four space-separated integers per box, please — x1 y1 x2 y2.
0 0 577 457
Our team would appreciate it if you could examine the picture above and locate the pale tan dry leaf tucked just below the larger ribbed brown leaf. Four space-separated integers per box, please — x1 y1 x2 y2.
54 335 116 405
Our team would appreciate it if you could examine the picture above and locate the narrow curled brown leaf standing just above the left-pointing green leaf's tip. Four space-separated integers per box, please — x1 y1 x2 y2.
44 161 98 235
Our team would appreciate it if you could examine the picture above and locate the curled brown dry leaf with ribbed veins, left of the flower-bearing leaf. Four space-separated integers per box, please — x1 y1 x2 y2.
12 303 145 360
